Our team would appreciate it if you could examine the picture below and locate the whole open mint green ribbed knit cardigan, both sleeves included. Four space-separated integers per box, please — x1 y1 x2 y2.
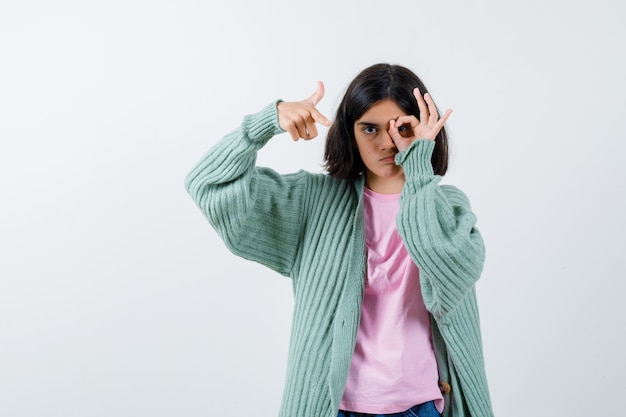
185 102 493 417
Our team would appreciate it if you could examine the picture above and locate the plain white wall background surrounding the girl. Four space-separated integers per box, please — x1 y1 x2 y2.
0 0 626 417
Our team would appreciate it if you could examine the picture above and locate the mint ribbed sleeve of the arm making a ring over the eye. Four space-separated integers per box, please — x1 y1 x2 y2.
398 140 485 316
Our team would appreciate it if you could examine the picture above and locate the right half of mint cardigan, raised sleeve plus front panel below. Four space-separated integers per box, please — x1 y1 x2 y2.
396 140 493 417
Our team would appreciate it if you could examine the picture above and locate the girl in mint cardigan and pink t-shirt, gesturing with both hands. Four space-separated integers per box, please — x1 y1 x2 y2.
186 64 493 417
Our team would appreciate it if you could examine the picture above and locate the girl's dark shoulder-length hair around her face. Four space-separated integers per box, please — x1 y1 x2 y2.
324 64 448 180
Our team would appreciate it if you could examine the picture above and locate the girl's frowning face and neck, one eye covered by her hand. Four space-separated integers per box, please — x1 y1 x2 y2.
354 99 407 194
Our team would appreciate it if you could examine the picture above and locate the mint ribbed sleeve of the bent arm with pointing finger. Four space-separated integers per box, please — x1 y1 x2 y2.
185 102 306 275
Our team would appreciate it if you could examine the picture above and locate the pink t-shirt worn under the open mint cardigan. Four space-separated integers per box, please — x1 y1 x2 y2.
340 188 443 414
